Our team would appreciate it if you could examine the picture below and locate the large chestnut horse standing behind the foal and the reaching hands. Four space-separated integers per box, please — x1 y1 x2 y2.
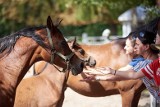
64 17 160 107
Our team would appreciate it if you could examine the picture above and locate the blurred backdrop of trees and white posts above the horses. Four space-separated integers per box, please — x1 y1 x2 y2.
0 0 160 43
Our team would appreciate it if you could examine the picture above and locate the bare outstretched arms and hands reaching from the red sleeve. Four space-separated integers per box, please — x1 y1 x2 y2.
84 67 144 81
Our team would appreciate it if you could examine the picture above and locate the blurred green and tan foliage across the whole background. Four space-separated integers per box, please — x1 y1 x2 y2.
0 0 159 36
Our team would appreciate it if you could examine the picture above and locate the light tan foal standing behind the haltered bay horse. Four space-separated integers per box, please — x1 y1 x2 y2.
14 40 96 107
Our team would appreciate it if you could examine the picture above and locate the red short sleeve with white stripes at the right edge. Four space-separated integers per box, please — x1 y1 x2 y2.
141 59 159 79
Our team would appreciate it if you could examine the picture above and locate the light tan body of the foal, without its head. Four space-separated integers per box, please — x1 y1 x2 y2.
14 61 66 107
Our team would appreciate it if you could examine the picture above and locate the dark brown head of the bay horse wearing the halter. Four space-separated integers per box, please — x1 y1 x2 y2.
33 16 84 75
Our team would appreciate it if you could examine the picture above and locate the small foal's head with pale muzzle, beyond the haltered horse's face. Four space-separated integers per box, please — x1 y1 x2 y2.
67 38 96 67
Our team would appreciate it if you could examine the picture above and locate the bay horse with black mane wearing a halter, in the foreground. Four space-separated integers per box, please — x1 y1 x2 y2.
0 16 83 107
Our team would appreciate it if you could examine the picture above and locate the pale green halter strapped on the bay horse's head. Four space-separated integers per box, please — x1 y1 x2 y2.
46 28 74 72
